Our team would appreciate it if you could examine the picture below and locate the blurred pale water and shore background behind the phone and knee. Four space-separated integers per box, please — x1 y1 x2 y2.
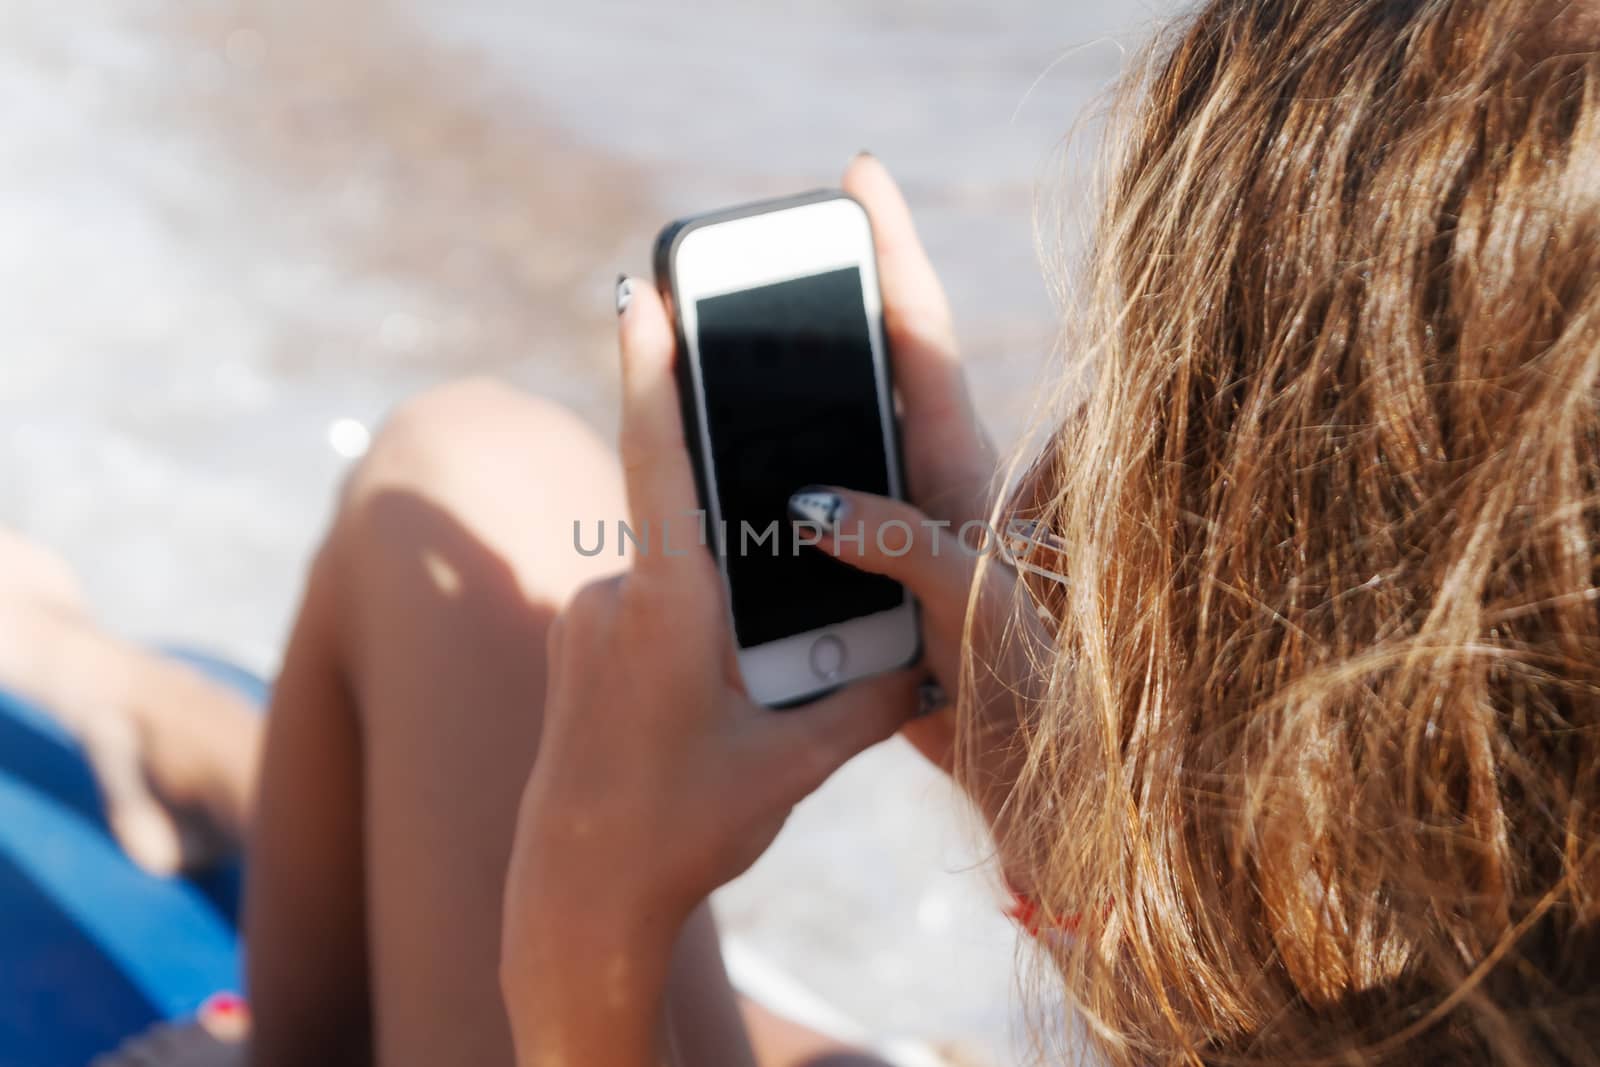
0 0 1168 1062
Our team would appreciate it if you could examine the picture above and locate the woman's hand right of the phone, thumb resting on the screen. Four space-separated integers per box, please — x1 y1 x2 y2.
816 155 1050 888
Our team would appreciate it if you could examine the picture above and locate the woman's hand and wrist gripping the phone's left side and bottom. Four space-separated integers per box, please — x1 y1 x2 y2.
502 268 917 1067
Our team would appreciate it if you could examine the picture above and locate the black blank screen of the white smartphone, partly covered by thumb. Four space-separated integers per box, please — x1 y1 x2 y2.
696 267 906 648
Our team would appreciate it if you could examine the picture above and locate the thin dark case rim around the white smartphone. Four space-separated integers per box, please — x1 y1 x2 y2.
654 189 922 709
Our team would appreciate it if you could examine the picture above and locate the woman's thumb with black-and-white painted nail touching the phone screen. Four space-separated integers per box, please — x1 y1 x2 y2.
789 485 976 611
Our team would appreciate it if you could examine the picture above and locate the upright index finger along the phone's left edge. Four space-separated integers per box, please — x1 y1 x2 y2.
618 278 704 571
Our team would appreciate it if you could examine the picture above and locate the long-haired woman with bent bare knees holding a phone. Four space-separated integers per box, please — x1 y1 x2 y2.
9 0 1600 1067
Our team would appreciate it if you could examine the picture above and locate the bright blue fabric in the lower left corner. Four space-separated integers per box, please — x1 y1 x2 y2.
0 653 266 1067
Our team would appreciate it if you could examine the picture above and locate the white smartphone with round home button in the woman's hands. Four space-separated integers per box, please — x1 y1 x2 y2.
656 192 925 707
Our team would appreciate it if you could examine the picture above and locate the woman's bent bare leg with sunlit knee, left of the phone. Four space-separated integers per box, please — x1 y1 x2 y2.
246 382 755 1067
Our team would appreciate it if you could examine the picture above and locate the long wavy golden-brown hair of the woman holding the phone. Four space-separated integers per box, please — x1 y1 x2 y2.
979 0 1600 1064
